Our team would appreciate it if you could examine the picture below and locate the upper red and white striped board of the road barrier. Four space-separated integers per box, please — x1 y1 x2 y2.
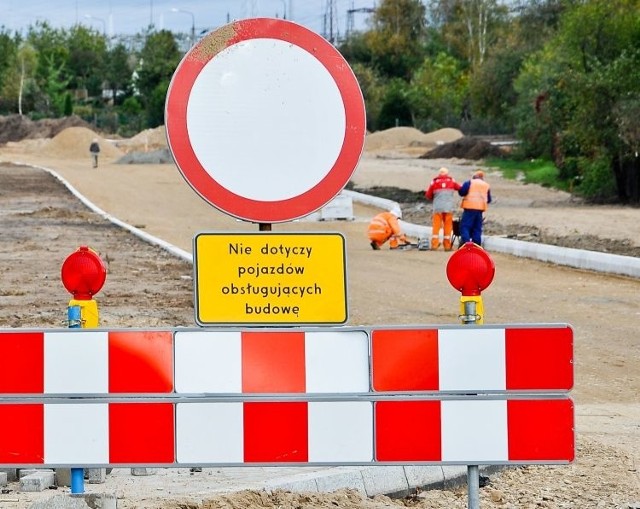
0 326 573 394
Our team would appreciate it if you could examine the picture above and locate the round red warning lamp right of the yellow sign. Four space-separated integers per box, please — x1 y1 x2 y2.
447 242 496 296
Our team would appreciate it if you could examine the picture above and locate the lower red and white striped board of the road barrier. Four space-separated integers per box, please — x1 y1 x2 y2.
0 398 574 466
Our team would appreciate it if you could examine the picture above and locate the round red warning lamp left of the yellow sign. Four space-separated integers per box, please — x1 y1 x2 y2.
61 246 107 300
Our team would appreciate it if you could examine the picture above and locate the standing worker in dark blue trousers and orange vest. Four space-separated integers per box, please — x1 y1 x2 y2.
458 170 491 246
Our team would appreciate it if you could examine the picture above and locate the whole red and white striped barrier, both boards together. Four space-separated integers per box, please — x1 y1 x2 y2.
0 326 574 467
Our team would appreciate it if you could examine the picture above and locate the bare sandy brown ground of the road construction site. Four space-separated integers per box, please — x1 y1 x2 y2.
0 124 640 509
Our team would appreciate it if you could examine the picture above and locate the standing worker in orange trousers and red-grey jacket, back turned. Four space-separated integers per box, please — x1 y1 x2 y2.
424 167 460 251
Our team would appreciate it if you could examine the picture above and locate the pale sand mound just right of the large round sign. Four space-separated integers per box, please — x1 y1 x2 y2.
364 127 463 151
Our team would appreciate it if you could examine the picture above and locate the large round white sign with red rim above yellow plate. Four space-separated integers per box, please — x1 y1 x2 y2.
165 18 366 223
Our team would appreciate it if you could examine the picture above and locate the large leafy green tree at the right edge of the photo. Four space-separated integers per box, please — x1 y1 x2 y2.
516 0 640 203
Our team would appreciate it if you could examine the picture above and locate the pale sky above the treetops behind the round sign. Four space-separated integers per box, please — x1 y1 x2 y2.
0 0 377 36
